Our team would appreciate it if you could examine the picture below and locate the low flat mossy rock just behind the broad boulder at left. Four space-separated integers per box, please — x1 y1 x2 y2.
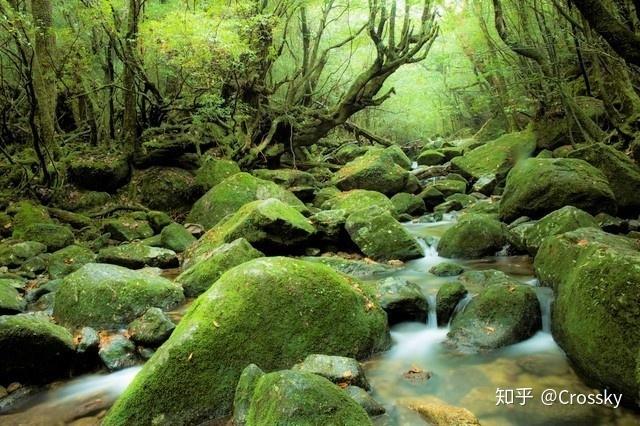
97 243 180 269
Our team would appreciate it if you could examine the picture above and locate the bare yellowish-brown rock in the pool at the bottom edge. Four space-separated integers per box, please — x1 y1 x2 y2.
401 397 480 426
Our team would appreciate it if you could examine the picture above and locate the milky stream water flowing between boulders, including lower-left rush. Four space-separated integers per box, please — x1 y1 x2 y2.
5 216 640 426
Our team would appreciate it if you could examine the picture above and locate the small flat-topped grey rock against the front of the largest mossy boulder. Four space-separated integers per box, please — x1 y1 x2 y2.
291 354 369 389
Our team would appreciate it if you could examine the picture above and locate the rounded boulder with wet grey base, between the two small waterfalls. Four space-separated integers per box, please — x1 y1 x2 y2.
448 284 542 352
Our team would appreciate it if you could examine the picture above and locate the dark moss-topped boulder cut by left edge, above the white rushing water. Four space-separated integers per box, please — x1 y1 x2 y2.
0 314 74 385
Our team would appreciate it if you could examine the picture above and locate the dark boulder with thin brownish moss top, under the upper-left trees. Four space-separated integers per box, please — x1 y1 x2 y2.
68 153 131 192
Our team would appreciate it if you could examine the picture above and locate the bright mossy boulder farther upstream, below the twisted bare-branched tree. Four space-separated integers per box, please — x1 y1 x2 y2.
333 150 410 195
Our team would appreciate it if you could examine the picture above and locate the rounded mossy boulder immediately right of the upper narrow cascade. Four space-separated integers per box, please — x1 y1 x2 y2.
438 214 509 259
